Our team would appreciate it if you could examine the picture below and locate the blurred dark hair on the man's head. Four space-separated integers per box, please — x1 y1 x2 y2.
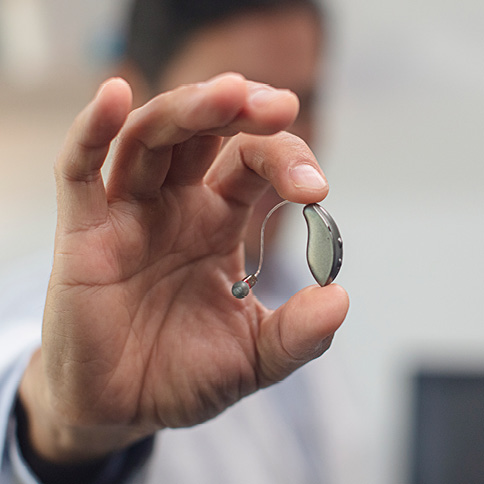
126 0 321 86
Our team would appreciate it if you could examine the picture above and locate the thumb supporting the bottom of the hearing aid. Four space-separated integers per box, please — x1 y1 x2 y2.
257 284 349 386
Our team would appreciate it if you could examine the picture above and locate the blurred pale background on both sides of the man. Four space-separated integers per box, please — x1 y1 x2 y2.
0 0 484 484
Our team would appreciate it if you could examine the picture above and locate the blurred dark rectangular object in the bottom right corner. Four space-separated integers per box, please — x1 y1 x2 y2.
410 371 484 484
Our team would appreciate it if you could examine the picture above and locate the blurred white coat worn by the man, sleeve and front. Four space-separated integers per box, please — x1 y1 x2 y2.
0 251 367 484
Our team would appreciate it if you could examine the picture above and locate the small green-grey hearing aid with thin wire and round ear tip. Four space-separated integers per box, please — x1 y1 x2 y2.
232 200 343 299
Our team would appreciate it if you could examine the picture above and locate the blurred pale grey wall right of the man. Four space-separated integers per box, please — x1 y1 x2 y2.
294 0 484 484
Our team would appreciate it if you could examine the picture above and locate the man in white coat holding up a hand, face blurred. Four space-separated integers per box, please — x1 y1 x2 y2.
0 0 361 484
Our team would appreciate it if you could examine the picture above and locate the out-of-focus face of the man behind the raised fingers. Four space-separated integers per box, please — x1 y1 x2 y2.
156 7 321 260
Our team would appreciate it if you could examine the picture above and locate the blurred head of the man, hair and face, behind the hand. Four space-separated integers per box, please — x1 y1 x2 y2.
119 0 326 270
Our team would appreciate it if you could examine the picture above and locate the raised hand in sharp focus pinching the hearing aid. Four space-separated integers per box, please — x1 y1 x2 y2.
20 74 348 462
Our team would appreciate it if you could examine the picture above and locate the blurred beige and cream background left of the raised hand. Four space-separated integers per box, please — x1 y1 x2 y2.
0 0 127 264
